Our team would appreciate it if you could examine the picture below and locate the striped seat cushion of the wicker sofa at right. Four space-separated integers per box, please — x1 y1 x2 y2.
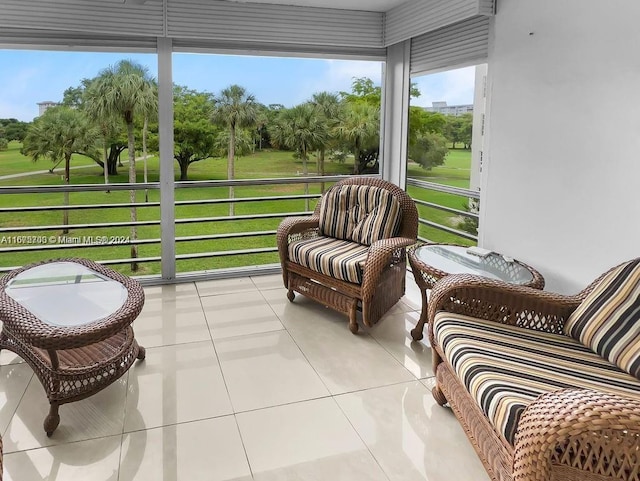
433 312 640 445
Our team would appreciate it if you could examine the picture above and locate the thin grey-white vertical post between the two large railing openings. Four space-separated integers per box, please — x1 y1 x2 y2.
158 37 176 280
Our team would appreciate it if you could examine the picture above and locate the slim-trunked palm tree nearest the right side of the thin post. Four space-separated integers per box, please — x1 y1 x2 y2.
211 85 258 216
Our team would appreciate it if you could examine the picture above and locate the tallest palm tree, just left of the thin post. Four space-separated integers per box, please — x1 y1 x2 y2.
86 60 158 271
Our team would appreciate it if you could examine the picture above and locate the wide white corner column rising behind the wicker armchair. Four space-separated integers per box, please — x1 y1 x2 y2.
380 40 411 188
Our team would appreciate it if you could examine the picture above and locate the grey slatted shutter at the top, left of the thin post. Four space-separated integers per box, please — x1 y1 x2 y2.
0 0 164 37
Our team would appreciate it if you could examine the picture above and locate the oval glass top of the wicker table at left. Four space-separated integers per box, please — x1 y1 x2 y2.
5 262 127 326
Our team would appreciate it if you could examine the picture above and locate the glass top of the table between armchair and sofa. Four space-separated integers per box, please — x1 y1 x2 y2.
415 244 533 284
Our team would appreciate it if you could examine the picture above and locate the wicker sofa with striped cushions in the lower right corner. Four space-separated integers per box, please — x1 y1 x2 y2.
428 259 640 481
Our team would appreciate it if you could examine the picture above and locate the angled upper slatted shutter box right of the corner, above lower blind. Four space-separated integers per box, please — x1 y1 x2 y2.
384 0 494 46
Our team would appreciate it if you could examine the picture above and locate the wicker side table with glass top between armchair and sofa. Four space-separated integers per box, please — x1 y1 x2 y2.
407 244 544 341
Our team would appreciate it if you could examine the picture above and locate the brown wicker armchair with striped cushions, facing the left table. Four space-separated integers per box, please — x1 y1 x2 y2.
277 177 418 333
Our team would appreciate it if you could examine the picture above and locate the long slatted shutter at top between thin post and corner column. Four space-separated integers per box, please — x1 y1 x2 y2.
167 0 383 48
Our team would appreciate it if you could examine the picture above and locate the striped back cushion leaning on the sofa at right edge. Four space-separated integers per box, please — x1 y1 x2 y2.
564 258 640 379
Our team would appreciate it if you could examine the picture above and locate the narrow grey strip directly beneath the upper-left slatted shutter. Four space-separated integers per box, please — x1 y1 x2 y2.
0 28 157 52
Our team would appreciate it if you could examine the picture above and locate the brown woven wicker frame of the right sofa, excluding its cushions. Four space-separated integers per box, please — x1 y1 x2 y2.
428 258 640 481
